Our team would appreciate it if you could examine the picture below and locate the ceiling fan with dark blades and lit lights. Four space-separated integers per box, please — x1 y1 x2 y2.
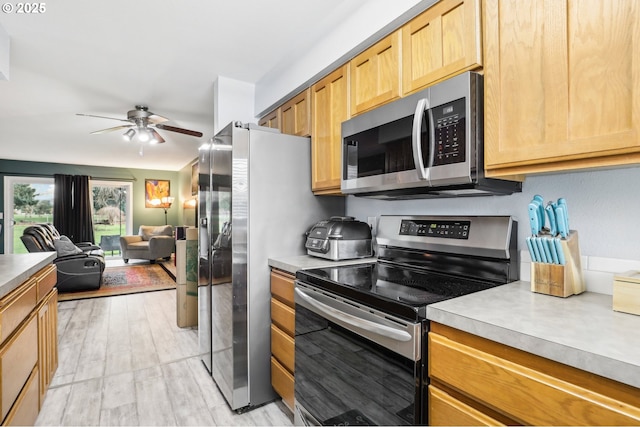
76 105 202 144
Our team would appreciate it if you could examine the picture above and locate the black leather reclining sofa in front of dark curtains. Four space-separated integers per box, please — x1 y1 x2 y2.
20 224 105 292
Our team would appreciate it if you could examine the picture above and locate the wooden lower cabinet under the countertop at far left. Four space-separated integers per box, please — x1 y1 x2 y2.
0 265 58 425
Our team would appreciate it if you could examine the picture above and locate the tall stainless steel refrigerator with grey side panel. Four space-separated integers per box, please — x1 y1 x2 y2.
198 122 344 410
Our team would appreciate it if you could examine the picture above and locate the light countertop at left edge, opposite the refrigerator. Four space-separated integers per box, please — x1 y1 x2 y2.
0 252 57 298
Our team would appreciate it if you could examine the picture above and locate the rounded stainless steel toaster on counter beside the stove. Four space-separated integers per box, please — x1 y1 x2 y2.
305 216 373 261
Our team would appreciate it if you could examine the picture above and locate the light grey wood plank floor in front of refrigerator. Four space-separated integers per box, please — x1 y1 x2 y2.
36 290 292 426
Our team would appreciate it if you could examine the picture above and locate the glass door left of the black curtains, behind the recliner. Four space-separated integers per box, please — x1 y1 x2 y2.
4 176 53 254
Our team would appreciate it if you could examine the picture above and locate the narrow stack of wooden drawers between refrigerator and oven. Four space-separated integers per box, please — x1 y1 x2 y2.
271 269 295 411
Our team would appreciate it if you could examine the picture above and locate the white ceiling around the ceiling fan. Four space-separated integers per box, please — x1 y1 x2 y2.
0 0 367 170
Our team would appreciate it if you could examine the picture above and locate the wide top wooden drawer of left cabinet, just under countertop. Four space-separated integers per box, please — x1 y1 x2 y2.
0 278 37 342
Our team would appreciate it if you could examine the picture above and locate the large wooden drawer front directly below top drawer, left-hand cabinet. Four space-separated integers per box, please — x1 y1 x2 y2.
0 314 38 419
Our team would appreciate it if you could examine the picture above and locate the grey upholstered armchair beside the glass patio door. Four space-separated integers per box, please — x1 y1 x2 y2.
120 225 175 264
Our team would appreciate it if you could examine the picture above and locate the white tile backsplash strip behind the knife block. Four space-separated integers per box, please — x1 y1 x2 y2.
520 251 640 295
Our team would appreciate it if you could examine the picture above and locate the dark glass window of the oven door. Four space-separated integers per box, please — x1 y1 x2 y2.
295 304 421 425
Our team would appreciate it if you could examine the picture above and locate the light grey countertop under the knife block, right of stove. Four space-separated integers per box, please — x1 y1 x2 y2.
427 281 640 388
